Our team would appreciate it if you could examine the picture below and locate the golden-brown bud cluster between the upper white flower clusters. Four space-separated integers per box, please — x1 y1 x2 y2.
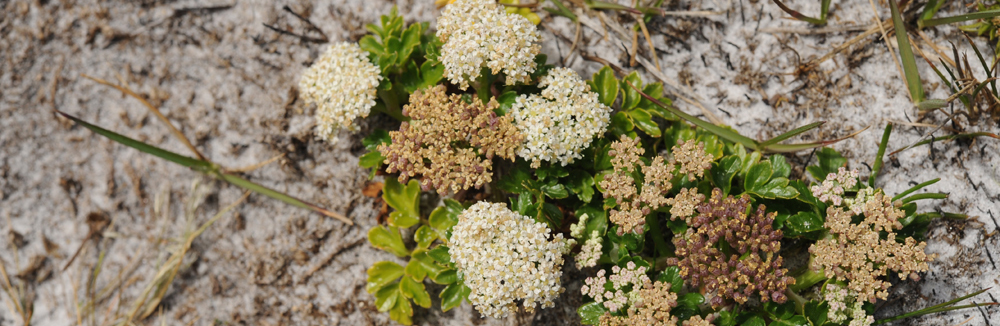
378 85 523 193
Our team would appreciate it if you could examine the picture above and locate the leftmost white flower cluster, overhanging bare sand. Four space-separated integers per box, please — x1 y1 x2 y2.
299 42 382 142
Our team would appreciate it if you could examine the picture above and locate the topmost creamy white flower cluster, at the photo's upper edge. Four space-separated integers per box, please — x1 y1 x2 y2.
437 0 541 90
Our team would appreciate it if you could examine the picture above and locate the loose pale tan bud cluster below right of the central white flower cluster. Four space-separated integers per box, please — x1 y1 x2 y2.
601 135 674 235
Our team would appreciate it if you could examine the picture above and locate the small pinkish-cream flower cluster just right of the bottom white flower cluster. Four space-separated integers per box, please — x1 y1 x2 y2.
580 262 650 312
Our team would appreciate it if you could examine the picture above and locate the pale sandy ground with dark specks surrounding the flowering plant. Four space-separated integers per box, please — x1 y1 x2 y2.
0 0 1000 325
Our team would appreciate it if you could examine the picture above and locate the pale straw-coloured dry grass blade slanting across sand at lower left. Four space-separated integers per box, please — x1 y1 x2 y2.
123 191 250 325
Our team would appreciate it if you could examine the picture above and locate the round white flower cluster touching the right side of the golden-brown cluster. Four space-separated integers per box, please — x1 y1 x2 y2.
509 68 611 168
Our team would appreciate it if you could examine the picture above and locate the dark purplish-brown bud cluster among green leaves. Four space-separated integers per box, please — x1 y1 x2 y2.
671 188 795 307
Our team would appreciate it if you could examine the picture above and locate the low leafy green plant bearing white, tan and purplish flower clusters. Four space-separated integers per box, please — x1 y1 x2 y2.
308 0 996 325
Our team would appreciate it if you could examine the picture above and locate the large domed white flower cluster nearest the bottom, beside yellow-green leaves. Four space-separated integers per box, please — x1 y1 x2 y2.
449 202 567 318
